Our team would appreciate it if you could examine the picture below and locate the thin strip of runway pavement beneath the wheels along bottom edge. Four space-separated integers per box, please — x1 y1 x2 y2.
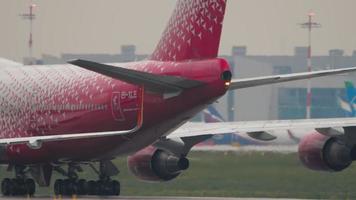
1 196 308 200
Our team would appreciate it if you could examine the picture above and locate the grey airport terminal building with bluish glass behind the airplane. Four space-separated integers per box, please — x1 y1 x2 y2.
34 45 356 121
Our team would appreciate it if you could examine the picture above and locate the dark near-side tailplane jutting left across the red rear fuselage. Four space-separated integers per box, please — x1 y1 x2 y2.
69 59 204 94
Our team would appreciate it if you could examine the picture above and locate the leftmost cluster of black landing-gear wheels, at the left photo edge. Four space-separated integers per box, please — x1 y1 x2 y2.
1 166 36 196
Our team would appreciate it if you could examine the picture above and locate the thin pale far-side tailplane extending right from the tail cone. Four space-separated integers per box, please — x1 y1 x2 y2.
229 67 356 90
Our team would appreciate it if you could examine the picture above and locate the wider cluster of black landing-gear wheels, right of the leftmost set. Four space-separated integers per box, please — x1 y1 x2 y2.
54 162 120 196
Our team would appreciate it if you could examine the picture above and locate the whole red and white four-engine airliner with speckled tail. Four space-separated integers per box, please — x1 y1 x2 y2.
0 0 356 196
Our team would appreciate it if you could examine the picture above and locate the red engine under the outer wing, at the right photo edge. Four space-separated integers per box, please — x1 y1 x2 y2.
298 132 352 172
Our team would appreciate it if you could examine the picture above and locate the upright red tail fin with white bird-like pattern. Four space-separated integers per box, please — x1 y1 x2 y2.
151 0 226 61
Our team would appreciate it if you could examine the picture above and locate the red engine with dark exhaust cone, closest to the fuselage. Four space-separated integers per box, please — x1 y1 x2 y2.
127 146 189 182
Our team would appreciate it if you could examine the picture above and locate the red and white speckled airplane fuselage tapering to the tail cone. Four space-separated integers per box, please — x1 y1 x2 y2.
0 59 229 164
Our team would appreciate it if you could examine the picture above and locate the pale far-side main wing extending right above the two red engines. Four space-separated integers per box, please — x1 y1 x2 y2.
167 118 356 141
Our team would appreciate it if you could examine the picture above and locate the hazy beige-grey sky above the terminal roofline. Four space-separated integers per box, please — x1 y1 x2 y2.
0 0 356 61
